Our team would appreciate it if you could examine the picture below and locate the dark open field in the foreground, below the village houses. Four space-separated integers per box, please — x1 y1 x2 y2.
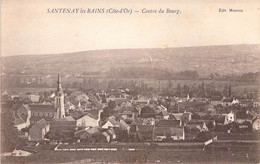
2 143 260 163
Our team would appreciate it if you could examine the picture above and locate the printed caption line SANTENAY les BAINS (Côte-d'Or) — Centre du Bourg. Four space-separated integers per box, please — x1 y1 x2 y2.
47 8 181 15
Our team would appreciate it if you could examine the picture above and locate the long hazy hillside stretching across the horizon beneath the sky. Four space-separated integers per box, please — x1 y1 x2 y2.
2 45 260 75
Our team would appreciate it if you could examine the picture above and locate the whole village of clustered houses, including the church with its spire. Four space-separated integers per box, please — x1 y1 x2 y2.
2 76 260 151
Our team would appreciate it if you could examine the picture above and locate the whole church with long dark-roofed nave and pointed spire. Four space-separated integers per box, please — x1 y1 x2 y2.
17 75 65 124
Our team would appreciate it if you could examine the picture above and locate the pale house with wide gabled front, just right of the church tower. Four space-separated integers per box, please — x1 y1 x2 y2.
76 114 99 127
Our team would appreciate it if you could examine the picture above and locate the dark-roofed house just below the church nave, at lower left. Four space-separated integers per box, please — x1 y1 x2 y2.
28 119 50 141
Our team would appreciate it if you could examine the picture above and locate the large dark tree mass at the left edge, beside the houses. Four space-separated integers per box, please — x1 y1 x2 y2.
1 106 18 152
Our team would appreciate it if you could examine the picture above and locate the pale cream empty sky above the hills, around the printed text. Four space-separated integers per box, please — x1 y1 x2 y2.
1 0 260 56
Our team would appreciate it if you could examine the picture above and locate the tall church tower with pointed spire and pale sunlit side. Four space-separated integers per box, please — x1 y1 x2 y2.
55 74 65 118
